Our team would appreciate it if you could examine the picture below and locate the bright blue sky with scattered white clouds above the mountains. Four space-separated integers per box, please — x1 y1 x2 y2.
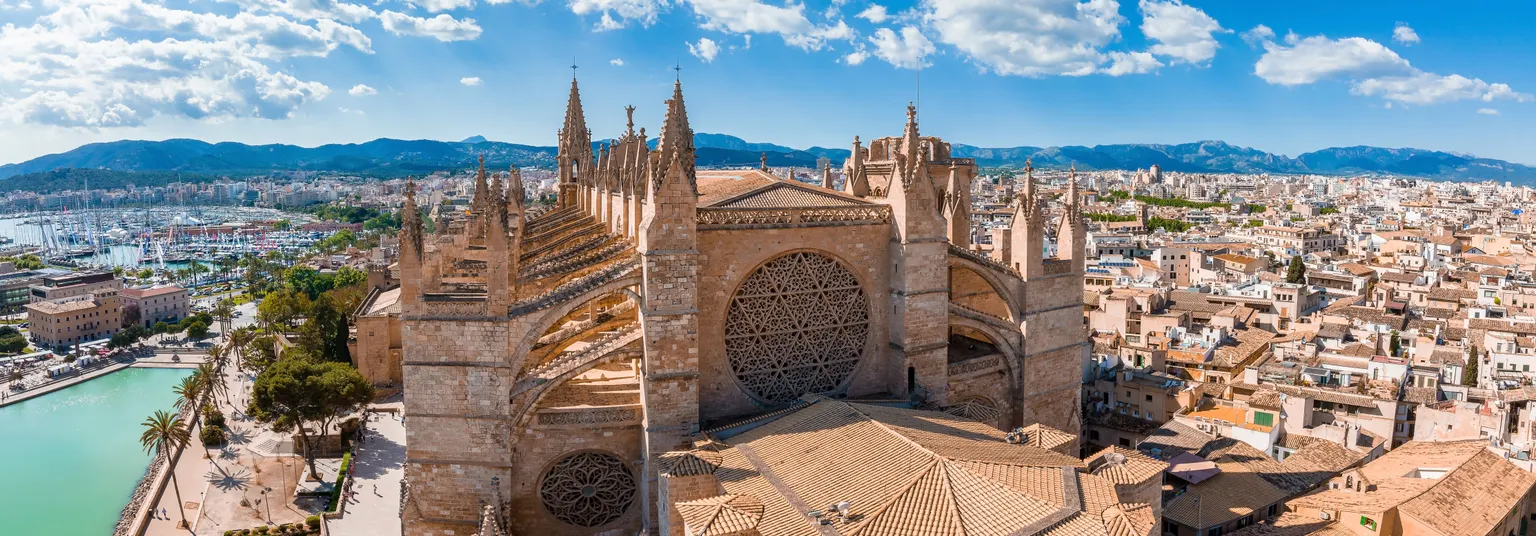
0 0 1536 164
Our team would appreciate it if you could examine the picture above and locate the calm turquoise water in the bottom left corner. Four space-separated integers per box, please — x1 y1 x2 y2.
0 369 192 536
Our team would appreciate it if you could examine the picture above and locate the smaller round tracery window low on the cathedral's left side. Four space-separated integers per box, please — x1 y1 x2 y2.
539 452 636 528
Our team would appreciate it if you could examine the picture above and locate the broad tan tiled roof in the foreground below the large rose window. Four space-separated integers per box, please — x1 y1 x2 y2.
703 399 1143 534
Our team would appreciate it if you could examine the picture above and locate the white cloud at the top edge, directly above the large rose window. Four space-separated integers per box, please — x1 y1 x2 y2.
688 0 854 51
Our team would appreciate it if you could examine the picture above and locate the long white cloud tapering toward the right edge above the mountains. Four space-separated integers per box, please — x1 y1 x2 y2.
1253 35 1531 104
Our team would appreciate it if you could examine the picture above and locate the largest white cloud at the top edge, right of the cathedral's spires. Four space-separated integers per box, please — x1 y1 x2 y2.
922 0 1126 77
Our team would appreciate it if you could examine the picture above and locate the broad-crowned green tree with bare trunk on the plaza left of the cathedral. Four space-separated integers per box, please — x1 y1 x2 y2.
250 358 373 476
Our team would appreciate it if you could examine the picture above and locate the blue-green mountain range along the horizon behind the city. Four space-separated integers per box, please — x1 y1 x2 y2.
0 134 1536 190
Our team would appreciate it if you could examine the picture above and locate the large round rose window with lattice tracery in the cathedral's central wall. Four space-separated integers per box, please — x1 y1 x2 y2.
725 252 869 404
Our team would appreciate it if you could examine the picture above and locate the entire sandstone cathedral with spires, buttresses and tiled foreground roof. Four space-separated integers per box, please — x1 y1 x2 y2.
398 80 1166 536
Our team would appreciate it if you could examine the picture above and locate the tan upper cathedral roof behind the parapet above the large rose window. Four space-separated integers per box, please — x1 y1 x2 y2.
699 169 872 209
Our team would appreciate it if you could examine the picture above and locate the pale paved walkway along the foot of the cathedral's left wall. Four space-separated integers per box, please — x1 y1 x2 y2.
327 404 406 536
